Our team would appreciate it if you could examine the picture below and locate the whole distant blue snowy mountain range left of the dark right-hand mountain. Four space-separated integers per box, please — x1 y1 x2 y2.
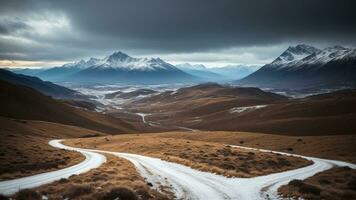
9 51 259 84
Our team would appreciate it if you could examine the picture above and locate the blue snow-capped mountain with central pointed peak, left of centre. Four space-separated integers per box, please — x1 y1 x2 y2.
39 51 199 84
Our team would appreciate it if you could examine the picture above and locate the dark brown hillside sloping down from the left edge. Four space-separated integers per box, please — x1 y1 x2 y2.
0 81 135 134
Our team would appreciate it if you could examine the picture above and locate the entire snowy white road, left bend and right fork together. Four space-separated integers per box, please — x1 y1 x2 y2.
0 140 356 200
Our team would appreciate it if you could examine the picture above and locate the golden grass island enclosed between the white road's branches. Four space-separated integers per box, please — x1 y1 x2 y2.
65 134 311 177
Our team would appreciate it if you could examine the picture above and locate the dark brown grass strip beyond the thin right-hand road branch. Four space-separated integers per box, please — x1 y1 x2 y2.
157 131 356 163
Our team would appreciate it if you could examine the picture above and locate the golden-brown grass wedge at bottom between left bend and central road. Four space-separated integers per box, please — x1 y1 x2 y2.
19 155 173 200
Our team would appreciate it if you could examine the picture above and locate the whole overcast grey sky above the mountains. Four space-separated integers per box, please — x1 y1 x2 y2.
0 0 356 66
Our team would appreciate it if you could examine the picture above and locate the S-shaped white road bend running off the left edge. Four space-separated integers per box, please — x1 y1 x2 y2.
0 140 106 195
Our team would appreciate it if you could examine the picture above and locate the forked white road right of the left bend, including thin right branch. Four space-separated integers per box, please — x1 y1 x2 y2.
83 145 356 200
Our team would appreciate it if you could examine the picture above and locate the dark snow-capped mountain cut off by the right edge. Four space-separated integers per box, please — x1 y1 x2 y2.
238 45 356 89
